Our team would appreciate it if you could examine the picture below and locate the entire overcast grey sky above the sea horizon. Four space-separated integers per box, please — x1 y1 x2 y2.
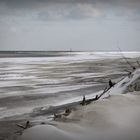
0 0 140 51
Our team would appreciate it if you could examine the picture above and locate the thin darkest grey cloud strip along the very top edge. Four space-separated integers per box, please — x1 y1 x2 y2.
0 0 140 7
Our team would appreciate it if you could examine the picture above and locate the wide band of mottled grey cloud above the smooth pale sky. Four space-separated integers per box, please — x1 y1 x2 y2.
0 0 140 21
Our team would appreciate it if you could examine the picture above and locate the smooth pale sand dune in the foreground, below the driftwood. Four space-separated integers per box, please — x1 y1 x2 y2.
15 93 140 140
